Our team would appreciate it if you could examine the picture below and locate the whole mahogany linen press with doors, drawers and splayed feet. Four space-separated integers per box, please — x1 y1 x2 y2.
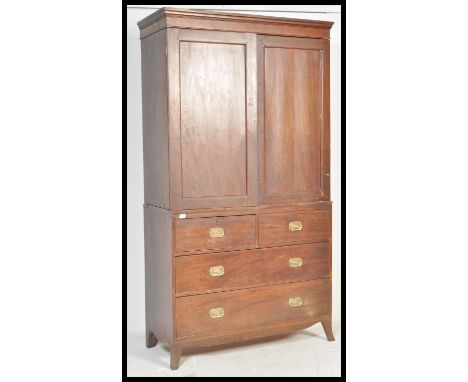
139 8 333 369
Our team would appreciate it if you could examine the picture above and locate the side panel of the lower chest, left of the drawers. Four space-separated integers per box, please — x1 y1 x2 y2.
144 205 173 343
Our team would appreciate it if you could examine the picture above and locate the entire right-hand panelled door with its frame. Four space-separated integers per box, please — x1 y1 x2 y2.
257 36 330 204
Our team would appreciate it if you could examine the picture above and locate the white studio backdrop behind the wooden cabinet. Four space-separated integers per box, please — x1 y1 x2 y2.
127 5 341 332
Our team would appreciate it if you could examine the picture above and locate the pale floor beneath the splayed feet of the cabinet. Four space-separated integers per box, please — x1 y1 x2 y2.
127 322 341 377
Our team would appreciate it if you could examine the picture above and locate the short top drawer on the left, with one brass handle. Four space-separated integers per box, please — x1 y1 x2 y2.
175 215 255 252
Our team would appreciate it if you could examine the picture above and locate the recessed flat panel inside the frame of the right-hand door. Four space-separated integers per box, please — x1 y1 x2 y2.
265 48 321 194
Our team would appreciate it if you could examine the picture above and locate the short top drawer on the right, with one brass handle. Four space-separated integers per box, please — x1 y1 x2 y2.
258 210 331 246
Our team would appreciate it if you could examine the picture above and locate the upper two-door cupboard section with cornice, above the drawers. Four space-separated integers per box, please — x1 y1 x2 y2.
139 9 331 210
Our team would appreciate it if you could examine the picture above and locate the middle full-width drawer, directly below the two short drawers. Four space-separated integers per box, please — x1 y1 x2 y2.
175 242 330 293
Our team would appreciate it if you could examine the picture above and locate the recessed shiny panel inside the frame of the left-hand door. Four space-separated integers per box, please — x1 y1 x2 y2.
180 41 247 198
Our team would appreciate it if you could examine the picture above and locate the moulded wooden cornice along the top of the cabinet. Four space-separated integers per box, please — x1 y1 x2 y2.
137 7 333 30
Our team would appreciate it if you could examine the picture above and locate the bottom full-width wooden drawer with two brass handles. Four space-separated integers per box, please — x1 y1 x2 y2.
176 279 330 337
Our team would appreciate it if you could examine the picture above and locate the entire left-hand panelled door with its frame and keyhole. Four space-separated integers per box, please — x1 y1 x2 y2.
167 28 258 209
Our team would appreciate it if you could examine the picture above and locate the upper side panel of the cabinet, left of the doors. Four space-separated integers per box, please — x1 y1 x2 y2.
141 30 169 208
